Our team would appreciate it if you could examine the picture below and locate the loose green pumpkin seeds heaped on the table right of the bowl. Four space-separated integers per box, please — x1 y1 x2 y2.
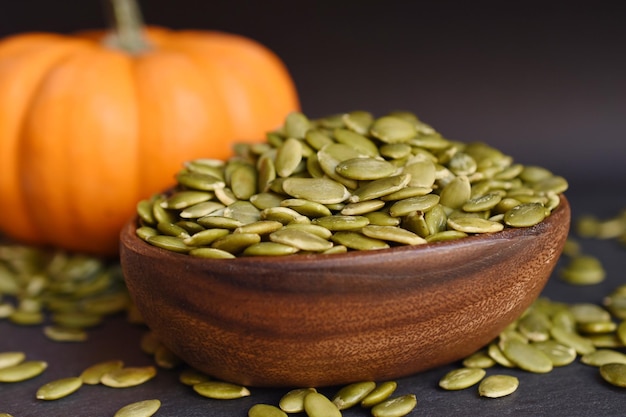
439 285 626 397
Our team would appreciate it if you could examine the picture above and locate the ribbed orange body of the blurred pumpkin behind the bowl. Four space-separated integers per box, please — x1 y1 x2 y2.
0 8 298 255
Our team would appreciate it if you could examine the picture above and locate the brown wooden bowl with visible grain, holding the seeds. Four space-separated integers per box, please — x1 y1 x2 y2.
121 193 570 387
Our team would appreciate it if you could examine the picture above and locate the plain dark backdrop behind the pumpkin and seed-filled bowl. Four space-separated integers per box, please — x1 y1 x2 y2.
0 0 626 186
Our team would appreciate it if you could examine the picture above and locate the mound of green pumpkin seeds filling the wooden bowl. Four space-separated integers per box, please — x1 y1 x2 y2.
137 111 568 258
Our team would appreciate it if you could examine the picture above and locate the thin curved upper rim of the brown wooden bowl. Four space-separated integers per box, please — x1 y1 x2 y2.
120 194 570 267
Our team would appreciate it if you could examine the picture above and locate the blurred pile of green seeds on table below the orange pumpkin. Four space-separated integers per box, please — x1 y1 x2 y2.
0 243 132 342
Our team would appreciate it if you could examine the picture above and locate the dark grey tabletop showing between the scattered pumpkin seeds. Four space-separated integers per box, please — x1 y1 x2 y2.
0 180 626 417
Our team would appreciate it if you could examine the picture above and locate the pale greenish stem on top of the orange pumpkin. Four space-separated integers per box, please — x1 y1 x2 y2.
106 0 149 54
